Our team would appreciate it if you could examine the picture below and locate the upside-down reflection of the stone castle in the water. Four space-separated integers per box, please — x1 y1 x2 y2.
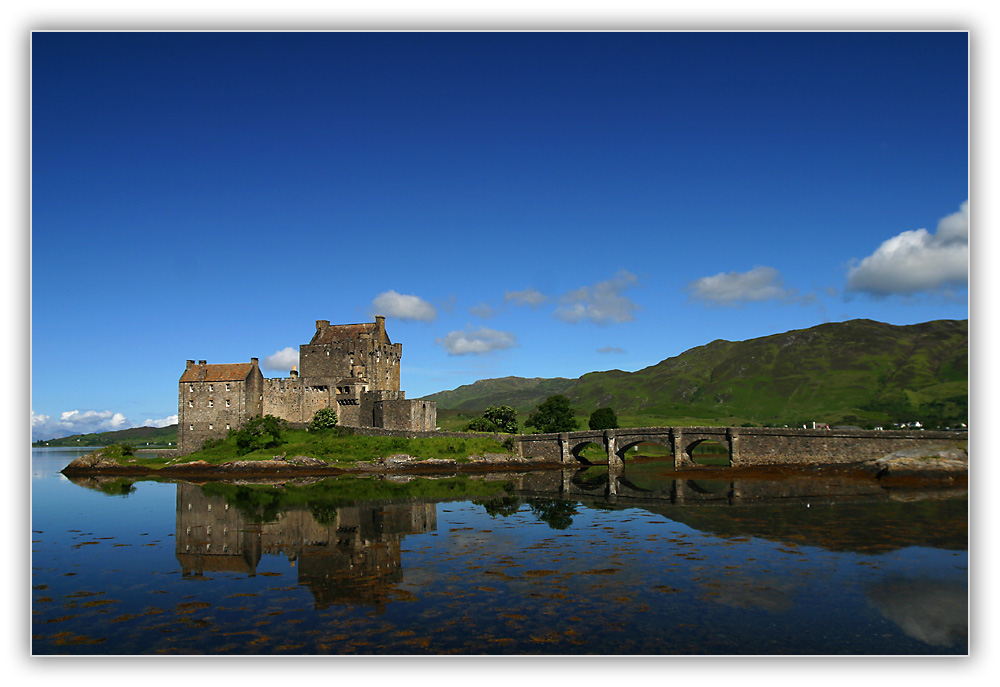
175 484 437 611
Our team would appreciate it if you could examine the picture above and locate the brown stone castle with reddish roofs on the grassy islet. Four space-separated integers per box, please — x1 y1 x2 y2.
177 316 437 453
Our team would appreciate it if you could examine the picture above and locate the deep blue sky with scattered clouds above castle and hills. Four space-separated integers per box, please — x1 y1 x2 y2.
30 32 969 438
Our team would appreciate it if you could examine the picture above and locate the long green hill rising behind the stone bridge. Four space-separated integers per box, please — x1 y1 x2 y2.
426 320 969 427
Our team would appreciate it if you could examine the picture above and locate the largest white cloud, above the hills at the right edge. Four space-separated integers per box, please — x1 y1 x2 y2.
847 201 969 296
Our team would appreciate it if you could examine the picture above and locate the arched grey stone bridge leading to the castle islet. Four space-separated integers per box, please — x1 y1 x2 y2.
513 427 969 469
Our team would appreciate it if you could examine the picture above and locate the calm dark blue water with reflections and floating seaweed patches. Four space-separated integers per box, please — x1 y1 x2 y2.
31 449 968 655
